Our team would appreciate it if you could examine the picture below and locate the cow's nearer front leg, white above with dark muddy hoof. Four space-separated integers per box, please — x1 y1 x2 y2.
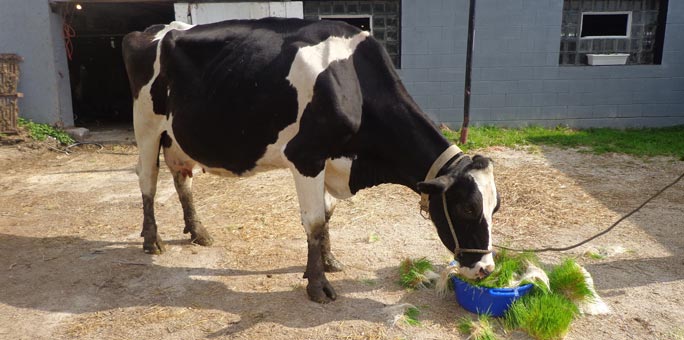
292 167 337 303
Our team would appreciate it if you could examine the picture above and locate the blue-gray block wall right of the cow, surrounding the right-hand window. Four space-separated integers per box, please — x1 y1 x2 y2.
401 0 684 128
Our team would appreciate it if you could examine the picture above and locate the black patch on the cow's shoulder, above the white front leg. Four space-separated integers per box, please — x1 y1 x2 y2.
285 59 362 177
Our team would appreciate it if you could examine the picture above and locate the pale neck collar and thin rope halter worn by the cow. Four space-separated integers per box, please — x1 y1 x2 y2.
420 144 492 255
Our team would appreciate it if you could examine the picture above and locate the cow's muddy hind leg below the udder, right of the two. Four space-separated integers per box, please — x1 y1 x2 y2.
173 170 214 246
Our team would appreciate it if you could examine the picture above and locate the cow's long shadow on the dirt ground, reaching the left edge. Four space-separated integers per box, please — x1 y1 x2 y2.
0 234 466 336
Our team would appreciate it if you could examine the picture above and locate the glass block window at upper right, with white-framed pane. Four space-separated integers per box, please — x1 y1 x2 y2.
559 0 667 65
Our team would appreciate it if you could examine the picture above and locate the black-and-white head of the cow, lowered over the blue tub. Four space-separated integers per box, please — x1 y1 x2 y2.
418 156 499 279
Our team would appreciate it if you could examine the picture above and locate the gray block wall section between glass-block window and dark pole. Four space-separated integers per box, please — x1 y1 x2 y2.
399 0 468 122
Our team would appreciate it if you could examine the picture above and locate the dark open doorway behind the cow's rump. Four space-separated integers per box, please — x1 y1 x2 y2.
63 2 174 128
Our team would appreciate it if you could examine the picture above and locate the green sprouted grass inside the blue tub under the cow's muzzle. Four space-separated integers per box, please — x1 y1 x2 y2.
461 250 539 288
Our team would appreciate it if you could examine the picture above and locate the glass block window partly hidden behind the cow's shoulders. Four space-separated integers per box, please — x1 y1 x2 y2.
304 0 401 68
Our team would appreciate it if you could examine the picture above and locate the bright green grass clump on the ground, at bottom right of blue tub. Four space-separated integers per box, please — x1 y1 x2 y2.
504 293 579 340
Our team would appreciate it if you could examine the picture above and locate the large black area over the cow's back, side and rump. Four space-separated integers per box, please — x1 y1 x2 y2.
124 18 372 174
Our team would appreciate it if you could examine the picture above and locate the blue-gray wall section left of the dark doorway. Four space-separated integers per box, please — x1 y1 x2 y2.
0 0 74 126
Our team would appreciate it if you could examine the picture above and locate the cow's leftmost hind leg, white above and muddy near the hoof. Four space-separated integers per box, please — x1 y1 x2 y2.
136 134 165 254
